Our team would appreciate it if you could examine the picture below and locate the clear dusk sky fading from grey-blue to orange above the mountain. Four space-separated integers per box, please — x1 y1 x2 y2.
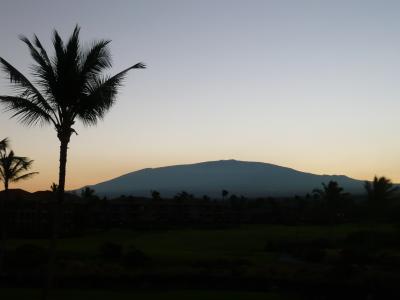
0 0 400 191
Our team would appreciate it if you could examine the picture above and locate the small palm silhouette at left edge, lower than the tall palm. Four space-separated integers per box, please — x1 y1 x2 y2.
0 150 38 191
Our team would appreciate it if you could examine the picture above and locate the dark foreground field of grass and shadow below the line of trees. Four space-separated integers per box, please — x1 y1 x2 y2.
0 224 400 300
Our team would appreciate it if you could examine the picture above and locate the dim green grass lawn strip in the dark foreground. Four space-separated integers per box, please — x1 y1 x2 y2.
8 224 393 262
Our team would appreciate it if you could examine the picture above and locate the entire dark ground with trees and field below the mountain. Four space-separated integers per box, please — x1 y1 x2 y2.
0 178 400 299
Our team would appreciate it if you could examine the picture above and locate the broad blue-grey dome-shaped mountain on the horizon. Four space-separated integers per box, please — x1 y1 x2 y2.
77 159 364 198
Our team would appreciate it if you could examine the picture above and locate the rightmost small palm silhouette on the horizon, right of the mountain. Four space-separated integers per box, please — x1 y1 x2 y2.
364 176 397 205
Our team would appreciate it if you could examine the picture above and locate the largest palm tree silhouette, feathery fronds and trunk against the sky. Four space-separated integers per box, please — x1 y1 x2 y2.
0 26 145 202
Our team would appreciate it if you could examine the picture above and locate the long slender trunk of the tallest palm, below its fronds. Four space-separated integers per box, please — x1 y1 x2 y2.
42 135 70 300
